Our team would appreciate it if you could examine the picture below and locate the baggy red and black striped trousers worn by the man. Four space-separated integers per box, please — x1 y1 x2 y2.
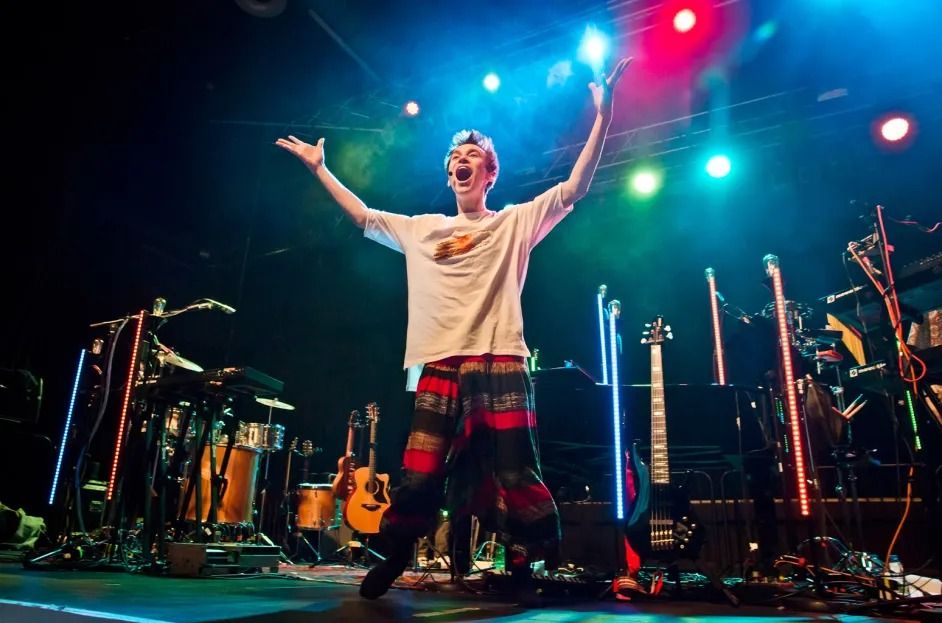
381 355 560 564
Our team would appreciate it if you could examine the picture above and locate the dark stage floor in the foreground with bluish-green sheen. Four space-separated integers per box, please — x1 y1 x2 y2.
0 564 928 623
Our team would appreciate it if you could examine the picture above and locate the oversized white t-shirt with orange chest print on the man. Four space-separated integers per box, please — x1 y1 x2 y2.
363 184 572 368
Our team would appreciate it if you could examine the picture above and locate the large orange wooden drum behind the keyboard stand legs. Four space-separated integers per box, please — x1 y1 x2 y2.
181 443 262 524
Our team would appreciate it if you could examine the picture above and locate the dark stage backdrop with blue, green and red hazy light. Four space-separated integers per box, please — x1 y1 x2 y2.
0 0 942 532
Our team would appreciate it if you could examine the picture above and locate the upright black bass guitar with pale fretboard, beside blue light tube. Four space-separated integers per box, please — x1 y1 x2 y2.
625 316 704 562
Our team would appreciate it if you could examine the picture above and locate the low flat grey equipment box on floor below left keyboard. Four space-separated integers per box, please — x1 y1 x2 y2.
167 543 281 577
